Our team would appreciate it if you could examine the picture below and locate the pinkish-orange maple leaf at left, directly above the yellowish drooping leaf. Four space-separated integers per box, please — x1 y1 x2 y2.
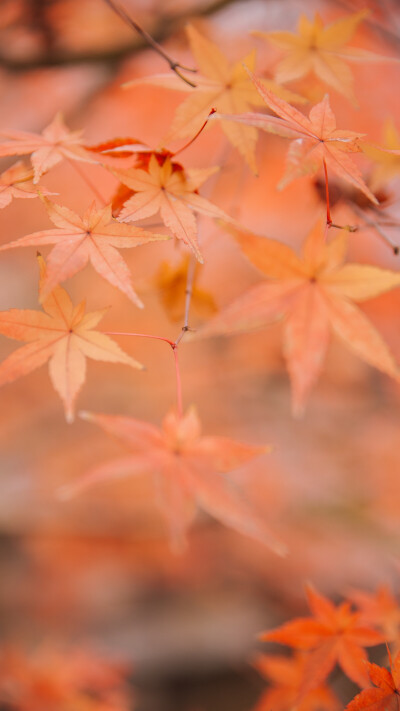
0 198 169 308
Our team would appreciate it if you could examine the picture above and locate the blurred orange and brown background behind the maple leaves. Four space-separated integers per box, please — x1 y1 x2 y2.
0 0 400 711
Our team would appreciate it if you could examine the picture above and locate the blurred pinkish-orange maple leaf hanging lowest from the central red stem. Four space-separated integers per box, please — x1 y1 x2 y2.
61 407 285 555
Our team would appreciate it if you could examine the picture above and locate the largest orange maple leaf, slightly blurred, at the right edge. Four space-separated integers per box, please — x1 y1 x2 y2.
198 222 400 415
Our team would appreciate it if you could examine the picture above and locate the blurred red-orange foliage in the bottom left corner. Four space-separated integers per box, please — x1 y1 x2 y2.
0 646 130 711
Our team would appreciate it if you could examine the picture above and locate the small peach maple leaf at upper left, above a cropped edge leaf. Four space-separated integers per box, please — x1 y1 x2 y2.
0 113 98 183
